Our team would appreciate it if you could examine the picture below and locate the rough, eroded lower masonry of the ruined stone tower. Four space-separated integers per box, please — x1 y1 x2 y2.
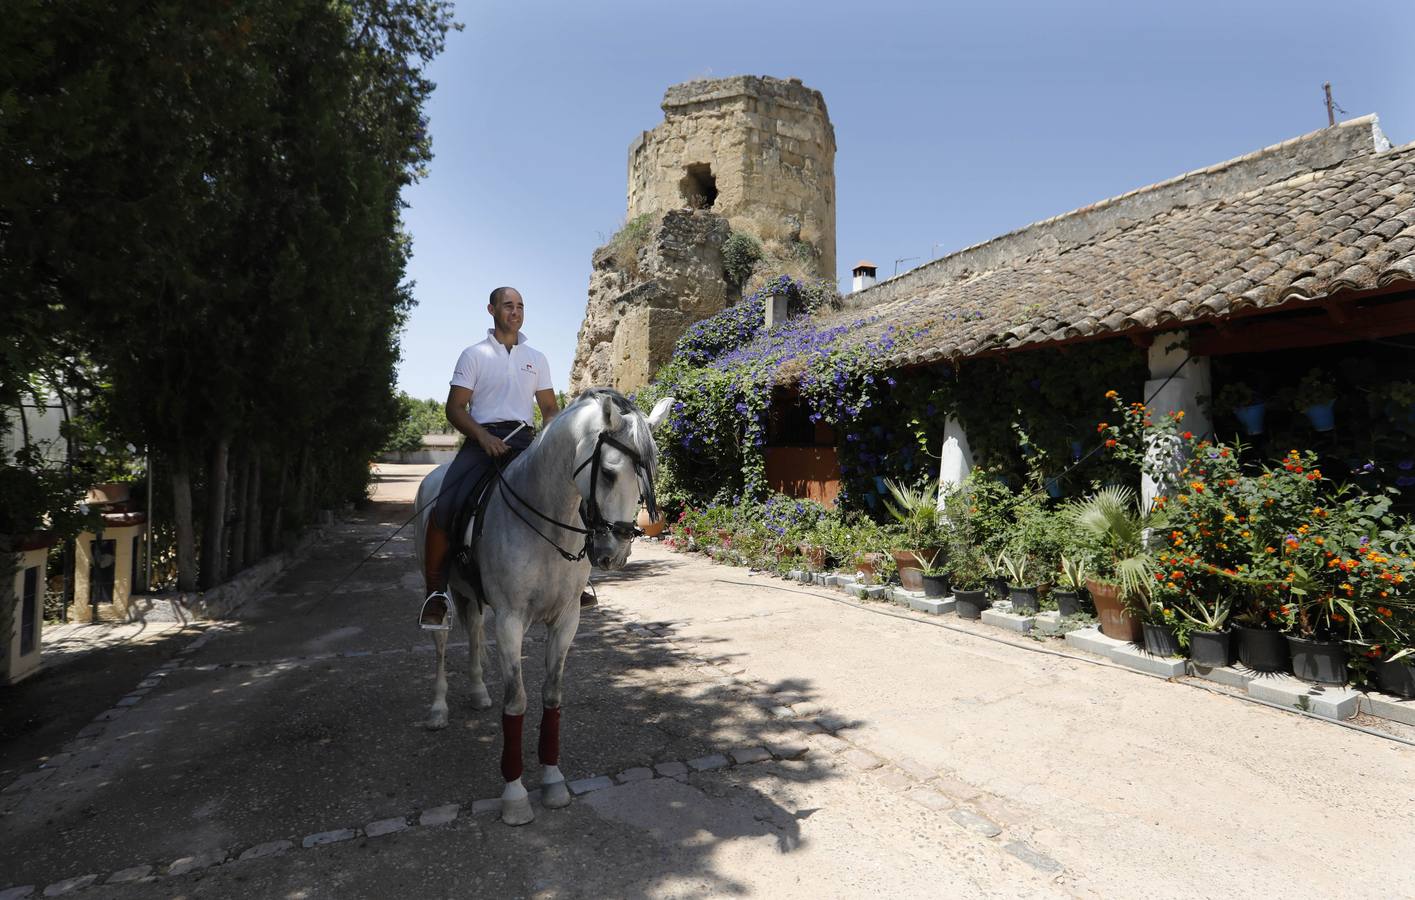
570 209 737 395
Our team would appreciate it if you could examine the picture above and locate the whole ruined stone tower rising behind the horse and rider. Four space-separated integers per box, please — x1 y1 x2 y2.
570 75 835 392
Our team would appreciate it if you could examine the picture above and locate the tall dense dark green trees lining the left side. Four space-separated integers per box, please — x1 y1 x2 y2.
0 0 456 583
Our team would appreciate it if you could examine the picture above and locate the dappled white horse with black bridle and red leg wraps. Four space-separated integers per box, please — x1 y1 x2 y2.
416 388 672 825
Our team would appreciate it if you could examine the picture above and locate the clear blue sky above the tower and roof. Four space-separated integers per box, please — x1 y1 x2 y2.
399 0 1415 399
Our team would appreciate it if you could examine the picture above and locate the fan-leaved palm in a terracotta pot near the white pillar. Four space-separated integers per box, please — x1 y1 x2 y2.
1070 485 1165 642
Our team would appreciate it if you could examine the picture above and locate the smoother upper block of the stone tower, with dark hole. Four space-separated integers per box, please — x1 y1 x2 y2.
628 75 835 276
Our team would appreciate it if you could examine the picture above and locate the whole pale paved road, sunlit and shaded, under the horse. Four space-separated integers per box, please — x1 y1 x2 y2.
0 467 1415 897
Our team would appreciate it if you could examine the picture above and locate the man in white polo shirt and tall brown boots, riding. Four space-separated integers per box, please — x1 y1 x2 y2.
419 287 593 631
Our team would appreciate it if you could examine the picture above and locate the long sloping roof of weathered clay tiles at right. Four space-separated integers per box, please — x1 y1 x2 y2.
809 144 1415 375
